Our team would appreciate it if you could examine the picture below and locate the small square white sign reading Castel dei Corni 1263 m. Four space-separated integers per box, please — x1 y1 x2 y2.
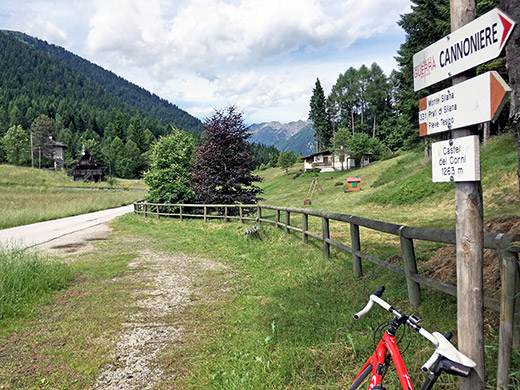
432 135 480 183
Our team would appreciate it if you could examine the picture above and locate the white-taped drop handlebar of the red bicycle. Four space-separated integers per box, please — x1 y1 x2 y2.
354 286 477 371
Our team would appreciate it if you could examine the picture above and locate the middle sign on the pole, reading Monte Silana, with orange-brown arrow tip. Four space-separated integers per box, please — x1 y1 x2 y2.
419 71 511 136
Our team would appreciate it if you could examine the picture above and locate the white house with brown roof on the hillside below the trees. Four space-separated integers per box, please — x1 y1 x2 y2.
303 150 372 172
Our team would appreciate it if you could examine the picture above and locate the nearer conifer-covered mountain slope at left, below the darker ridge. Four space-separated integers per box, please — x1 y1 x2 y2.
0 30 202 178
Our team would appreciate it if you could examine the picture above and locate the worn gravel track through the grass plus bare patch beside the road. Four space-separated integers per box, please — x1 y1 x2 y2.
40 224 226 390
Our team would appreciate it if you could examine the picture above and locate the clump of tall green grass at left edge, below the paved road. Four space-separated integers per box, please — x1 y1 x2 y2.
0 247 73 320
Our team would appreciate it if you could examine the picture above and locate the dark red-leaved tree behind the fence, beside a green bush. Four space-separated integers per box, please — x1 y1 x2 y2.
192 106 262 204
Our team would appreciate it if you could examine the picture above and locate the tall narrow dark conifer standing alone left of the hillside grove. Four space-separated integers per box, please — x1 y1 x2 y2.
309 79 332 151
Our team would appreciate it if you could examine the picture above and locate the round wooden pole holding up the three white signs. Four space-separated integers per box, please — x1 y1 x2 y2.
450 0 485 390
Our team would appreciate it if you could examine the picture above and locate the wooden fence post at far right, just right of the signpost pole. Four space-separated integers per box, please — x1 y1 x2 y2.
497 249 518 390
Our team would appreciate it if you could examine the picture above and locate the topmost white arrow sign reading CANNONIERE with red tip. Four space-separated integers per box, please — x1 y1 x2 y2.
413 8 515 91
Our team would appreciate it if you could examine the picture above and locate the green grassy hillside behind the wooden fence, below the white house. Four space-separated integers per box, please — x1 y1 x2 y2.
259 134 520 229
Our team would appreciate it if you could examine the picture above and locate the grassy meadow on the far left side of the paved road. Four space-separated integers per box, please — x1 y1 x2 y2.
0 165 146 229
